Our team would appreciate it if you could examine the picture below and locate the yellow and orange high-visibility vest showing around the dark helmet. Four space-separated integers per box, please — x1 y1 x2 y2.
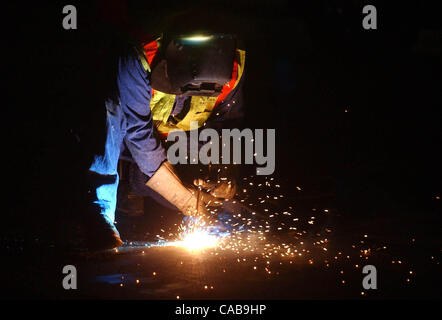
137 41 246 138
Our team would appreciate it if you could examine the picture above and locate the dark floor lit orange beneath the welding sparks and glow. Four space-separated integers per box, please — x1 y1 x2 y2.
2 175 442 299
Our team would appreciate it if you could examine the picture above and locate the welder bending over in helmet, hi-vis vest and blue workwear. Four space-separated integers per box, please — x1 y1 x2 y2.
85 30 245 249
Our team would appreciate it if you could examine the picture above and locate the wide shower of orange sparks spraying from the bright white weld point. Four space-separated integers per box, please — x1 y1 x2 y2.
117 170 439 299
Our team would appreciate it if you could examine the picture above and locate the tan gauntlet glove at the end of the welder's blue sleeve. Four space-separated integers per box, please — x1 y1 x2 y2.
146 161 209 216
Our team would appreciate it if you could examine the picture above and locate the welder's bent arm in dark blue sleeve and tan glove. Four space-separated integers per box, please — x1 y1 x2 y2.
118 48 204 215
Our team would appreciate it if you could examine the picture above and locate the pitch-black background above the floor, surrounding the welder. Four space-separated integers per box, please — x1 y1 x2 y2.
2 0 442 249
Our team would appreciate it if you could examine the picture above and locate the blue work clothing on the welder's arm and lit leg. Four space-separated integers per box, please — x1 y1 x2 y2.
89 50 166 225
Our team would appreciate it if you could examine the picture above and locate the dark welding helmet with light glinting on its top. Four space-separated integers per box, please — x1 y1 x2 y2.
151 34 236 97
